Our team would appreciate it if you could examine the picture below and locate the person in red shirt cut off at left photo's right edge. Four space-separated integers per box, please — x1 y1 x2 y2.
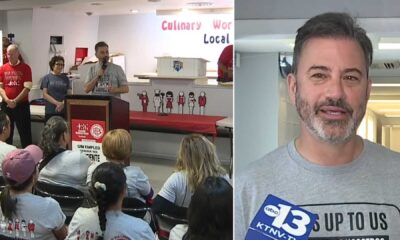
217 44 233 82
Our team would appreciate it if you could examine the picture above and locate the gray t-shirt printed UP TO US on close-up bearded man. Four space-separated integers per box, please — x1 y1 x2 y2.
235 140 400 240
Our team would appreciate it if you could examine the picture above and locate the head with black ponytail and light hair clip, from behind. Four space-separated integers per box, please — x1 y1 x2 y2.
90 162 126 239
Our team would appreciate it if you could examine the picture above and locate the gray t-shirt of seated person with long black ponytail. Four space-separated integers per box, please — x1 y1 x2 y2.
66 207 155 240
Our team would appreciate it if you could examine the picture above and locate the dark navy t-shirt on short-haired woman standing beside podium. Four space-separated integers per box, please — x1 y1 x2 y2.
40 73 71 114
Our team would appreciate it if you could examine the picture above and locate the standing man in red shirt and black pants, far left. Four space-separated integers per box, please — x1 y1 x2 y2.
0 44 32 148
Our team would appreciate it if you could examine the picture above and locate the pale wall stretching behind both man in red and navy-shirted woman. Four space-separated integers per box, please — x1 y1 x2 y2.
0 9 99 99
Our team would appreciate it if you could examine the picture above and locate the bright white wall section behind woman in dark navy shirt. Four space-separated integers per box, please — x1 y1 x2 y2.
29 9 99 99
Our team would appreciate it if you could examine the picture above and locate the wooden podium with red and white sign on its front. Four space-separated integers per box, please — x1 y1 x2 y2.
65 95 129 165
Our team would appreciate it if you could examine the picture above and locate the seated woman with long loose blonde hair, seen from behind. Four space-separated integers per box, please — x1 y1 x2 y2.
152 134 229 218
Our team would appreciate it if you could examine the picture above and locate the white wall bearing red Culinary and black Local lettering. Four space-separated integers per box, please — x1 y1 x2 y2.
99 13 234 79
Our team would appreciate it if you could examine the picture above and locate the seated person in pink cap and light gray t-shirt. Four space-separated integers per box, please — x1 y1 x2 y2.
0 145 67 239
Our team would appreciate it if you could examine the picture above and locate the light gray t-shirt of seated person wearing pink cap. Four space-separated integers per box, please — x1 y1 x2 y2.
0 193 65 240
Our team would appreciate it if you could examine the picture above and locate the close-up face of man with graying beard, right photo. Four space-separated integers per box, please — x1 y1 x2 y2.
288 38 371 144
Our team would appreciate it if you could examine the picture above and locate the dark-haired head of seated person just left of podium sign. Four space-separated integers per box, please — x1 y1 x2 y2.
39 116 70 157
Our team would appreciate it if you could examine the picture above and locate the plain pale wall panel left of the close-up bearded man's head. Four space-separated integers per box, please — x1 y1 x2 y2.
234 53 280 174
